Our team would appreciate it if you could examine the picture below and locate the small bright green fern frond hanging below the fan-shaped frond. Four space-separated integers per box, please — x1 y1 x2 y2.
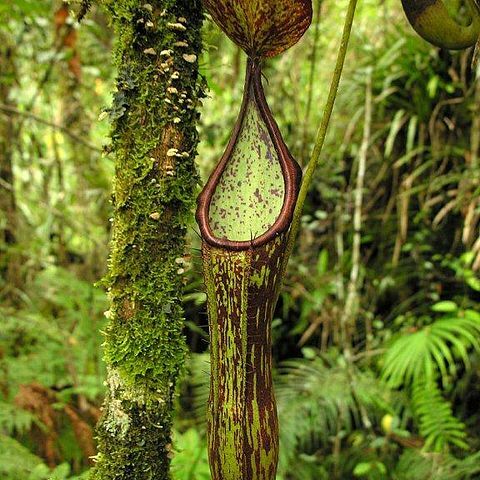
412 382 468 452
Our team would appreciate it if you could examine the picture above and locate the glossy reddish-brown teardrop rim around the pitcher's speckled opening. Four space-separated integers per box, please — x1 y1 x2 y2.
196 59 302 251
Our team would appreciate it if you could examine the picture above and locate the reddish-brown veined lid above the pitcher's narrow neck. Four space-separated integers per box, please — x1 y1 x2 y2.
203 0 312 57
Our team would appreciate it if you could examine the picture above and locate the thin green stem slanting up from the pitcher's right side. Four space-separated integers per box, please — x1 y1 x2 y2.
284 0 358 268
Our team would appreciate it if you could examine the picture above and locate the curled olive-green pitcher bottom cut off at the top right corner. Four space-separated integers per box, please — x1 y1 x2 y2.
402 0 480 50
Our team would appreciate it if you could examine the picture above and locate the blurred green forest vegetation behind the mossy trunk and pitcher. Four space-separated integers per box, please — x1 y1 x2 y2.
0 0 480 480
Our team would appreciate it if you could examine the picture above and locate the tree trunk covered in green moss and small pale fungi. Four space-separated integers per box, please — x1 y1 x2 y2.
91 0 202 480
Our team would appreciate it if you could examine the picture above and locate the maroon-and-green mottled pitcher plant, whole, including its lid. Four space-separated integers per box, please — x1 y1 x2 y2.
197 0 312 480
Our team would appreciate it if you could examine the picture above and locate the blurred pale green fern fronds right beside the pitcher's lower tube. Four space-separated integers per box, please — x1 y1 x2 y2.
276 358 390 471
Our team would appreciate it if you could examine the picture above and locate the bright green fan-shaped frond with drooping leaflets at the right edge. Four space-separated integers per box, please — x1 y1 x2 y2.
382 310 480 388
